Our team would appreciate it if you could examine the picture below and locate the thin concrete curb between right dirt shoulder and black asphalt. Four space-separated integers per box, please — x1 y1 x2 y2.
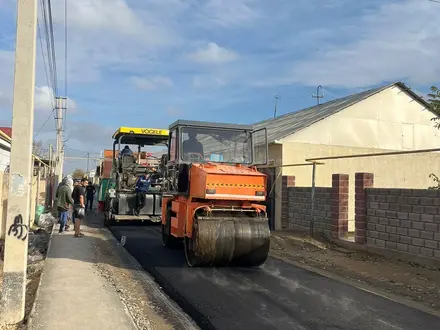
269 253 440 317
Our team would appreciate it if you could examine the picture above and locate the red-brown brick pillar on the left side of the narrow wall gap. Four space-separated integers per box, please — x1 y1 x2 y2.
331 174 348 238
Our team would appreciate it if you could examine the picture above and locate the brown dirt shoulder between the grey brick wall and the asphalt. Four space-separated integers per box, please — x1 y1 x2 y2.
270 232 440 312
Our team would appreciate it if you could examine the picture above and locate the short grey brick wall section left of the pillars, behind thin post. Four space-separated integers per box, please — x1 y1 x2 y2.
287 187 332 237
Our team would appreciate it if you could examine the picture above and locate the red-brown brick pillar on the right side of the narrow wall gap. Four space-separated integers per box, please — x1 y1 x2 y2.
354 173 374 244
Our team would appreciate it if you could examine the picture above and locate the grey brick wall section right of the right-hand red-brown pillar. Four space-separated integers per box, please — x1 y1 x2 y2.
365 188 440 259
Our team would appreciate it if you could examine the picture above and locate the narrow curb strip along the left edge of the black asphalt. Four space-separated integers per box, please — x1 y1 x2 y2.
100 228 200 330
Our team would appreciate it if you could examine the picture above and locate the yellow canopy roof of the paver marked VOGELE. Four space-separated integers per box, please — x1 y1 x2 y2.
113 126 169 146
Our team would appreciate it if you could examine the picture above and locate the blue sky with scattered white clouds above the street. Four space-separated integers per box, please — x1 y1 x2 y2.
0 0 440 172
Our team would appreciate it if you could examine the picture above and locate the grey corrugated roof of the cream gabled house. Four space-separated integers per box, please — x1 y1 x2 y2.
254 82 424 143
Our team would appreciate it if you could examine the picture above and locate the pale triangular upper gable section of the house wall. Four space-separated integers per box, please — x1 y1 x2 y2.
282 86 440 150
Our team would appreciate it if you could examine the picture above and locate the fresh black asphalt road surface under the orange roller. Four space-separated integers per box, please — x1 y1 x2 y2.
111 226 440 330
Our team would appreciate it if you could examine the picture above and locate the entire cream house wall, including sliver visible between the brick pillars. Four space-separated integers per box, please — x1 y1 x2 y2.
282 87 440 231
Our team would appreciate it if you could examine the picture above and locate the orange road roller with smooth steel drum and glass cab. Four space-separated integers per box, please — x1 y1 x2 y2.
162 120 270 266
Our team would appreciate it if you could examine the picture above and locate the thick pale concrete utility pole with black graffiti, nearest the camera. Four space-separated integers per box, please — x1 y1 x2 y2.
0 0 37 324
